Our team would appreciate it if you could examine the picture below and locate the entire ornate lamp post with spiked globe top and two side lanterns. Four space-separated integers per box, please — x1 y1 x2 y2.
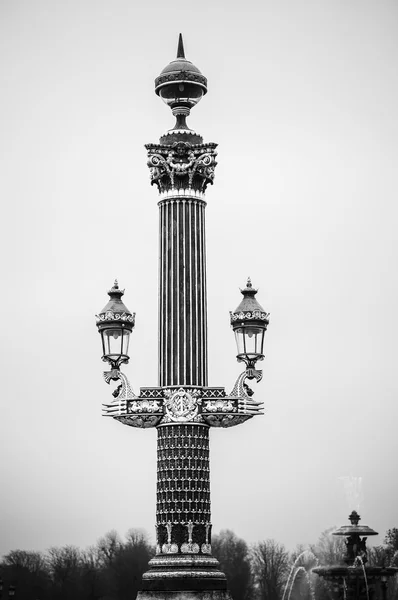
97 36 269 600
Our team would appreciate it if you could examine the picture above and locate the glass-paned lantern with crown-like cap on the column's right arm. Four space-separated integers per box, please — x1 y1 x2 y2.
230 278 269 369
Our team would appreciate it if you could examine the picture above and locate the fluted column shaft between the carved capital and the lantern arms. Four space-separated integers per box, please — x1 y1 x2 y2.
159 197 207 387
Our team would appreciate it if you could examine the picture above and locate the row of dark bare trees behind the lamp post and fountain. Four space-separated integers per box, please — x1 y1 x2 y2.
0 528 398 600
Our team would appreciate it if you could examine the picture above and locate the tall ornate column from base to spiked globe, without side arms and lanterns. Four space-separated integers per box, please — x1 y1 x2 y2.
143 38 226 591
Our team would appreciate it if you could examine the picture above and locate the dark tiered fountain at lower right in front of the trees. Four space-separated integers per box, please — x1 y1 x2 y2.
313 510 398 600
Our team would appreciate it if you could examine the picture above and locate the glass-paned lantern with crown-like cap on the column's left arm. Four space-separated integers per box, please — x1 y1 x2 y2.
96 280 135 369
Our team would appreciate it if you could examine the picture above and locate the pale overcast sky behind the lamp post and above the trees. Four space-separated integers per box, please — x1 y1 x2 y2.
0 0 398 553
